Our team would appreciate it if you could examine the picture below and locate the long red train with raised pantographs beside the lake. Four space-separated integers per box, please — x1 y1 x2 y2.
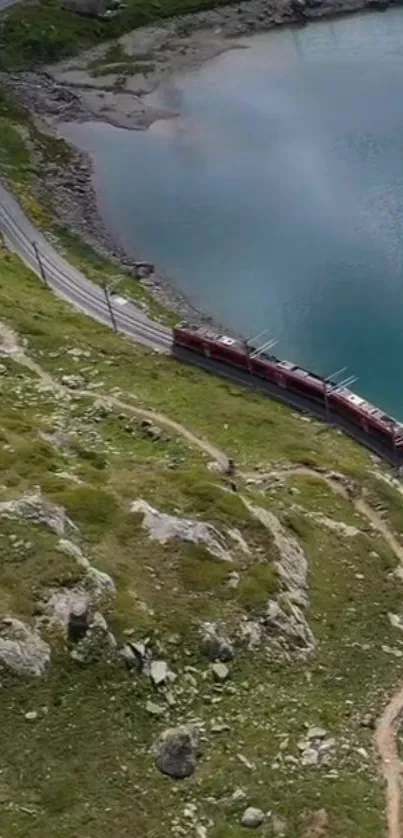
173 323 403 449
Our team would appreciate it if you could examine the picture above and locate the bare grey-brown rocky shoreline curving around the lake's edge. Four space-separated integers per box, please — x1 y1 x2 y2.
0 0 396 319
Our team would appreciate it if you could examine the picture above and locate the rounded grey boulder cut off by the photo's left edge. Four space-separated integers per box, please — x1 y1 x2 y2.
0 617 50 677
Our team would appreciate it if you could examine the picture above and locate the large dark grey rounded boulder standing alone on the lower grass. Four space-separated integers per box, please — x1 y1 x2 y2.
154 725 199 780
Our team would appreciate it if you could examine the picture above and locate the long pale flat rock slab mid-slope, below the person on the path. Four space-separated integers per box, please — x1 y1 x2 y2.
130 500 232 562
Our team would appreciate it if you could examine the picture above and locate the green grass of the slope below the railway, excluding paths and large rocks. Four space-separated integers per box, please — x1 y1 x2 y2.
0 244 403 838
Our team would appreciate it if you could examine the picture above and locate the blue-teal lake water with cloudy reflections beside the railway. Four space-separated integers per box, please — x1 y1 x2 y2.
65 9 403 419
